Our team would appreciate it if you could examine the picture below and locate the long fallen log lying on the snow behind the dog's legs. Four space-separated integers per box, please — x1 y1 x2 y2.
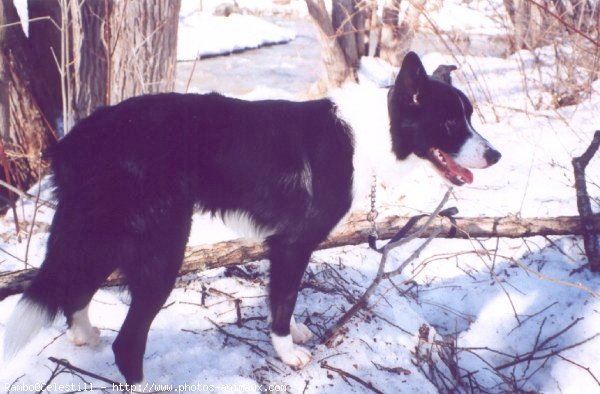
0 215 600 300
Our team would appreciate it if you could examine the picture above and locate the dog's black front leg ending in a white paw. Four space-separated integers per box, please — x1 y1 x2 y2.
268 236 313 369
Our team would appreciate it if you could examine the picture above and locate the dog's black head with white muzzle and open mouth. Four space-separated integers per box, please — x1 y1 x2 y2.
388 52 501 185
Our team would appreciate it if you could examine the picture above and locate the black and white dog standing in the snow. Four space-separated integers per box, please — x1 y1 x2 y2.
4 52 500 384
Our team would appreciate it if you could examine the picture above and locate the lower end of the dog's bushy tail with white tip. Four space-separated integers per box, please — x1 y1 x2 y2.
4 267 58 361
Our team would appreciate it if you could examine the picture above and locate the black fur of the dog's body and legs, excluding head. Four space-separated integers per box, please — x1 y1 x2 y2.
35 94 353 381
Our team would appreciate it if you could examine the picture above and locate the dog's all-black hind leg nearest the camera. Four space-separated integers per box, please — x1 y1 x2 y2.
112 204 192 384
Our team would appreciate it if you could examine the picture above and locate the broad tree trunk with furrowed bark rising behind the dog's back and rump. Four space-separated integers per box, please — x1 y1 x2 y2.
62 0 181 124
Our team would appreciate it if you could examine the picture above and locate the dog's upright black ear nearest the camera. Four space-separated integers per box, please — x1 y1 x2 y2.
394 52 429 104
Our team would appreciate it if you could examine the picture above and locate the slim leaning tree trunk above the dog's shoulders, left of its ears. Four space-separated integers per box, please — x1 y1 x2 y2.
306 0 355 86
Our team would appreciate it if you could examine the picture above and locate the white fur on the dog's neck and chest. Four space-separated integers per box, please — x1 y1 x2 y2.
330 84 402 209
